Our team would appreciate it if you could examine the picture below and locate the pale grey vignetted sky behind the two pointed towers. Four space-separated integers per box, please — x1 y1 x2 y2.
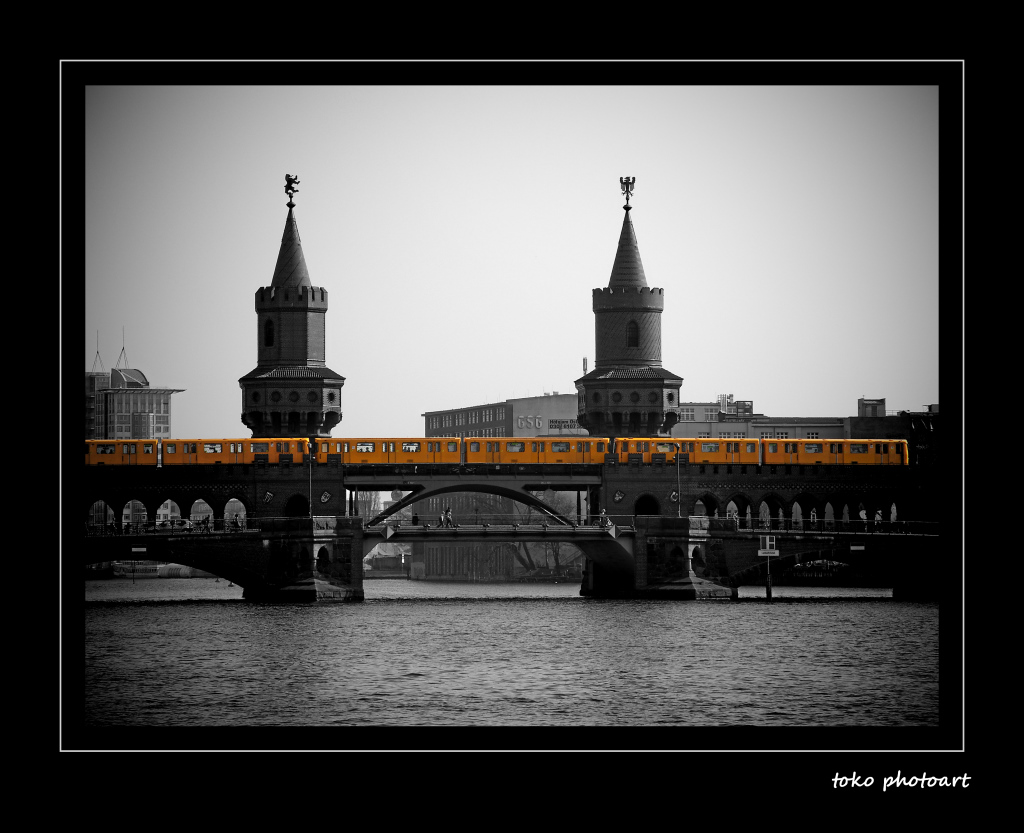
83 85 939 438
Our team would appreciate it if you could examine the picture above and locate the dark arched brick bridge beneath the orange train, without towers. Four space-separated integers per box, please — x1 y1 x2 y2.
78 462 942 600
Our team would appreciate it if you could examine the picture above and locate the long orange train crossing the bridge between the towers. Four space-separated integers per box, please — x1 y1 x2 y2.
85 436 909 466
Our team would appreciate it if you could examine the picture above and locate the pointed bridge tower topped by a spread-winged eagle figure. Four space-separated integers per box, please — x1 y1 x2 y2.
575 177 683 436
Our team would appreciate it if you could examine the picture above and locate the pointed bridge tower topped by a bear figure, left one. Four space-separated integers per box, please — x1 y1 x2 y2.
239 176 345 438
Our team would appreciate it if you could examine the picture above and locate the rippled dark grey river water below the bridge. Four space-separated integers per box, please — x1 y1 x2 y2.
70 579 939 748
